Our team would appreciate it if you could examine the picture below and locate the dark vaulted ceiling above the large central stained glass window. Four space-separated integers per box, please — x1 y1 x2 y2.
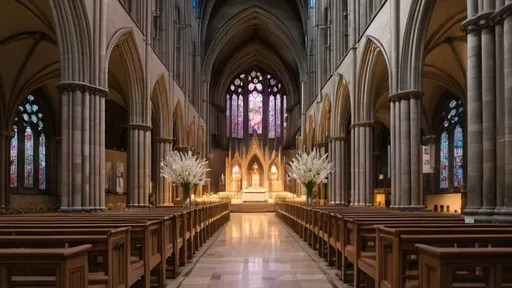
201 0 306 103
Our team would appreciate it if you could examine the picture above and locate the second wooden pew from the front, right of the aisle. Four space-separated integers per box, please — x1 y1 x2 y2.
372 224 512 288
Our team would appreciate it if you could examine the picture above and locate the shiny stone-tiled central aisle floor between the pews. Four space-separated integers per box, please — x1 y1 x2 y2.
180 213 336 288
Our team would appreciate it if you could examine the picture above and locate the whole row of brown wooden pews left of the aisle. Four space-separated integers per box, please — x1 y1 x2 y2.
0 201 230 288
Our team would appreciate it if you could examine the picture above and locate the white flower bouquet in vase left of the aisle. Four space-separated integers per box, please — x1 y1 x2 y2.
160 151 210 206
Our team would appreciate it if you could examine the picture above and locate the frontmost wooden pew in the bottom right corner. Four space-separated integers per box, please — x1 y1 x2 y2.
416 244 512 288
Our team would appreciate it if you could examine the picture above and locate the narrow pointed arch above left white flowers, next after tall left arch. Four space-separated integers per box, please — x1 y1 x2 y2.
151 75 171 138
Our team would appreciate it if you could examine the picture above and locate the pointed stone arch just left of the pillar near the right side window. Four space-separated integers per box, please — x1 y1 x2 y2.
353 36 391 122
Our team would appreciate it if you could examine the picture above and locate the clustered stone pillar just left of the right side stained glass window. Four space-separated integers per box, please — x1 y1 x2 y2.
390 90 424 210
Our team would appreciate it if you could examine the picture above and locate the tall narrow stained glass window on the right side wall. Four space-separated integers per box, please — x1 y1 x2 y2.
439 100 464 189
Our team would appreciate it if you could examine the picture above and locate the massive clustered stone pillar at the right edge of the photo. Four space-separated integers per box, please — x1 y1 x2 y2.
462 0 512 220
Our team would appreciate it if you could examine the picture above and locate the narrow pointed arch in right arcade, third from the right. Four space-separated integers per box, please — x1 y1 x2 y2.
331 75 351 136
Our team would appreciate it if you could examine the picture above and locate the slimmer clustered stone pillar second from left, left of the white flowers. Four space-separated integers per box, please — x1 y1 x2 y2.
128 123 151 207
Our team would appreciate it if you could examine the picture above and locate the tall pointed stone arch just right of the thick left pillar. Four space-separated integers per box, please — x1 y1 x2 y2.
105 28 147 124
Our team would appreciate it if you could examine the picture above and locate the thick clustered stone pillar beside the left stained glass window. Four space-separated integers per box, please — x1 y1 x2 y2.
59 82 108 211
